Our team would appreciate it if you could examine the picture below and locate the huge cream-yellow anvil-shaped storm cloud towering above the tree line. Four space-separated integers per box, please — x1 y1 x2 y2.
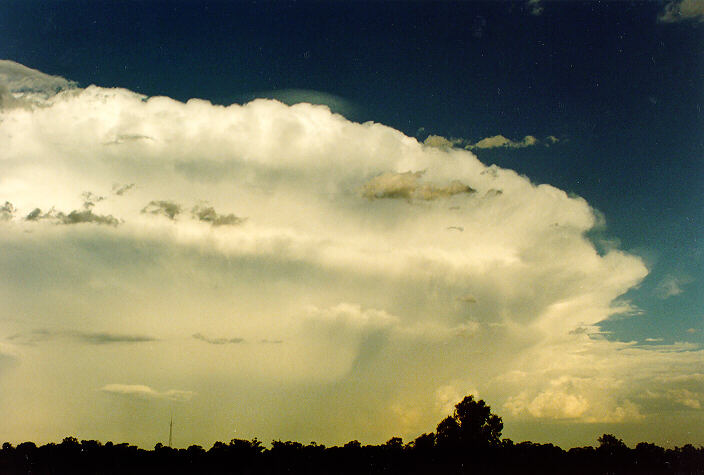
0 60 704 445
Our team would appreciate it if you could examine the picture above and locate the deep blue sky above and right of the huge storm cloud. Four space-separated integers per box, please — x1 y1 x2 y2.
0 1 704 342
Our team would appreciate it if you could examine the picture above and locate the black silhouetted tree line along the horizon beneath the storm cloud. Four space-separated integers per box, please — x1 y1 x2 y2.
0 396 704 475
